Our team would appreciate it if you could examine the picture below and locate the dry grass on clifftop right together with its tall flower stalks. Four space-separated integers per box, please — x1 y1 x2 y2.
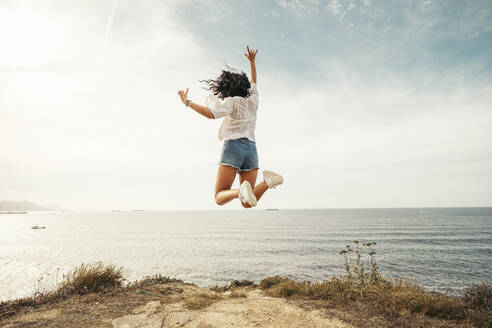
260 241 492 327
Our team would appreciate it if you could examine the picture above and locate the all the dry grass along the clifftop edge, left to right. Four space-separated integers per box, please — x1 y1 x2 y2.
0 241 492 328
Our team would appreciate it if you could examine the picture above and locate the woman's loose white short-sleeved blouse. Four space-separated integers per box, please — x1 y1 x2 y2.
205 83 258 141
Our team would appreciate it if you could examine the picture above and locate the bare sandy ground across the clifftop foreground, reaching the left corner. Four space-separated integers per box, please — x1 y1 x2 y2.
0 283 352 328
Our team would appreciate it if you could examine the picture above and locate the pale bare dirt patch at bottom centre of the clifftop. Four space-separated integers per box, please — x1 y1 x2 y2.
112 290 349 328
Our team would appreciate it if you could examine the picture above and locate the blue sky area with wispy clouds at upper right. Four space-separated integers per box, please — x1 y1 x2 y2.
167 0 492 87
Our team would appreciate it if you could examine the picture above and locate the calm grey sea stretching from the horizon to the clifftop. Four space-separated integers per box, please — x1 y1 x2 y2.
0 208 492 301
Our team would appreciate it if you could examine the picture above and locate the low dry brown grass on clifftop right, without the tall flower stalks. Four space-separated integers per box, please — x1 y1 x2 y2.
260 277 492 327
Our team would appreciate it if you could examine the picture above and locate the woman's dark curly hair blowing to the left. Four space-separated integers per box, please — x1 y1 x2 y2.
200 70 251 99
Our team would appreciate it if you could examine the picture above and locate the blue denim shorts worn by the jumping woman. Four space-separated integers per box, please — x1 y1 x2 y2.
219 138 258 172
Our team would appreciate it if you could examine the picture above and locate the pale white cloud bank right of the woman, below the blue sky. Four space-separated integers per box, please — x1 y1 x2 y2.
258 68 492 207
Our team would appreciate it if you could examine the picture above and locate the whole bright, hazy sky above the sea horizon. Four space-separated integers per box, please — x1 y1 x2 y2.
0 0 492 210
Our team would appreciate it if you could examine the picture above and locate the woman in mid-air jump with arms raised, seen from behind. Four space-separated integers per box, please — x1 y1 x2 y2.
178 46 284 208
